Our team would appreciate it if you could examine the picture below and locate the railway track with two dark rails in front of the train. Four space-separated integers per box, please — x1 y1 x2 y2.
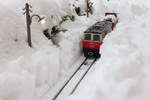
51 58 97 100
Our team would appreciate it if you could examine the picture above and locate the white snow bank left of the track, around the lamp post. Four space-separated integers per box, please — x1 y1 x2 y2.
0 0 94 100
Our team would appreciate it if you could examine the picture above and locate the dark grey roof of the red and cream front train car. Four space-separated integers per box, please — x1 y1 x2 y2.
85 21 111 34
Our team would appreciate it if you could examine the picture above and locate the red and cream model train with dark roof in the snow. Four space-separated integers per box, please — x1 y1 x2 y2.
81 12 118 58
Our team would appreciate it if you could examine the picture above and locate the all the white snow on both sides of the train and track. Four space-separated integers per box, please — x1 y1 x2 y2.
0 0 150 100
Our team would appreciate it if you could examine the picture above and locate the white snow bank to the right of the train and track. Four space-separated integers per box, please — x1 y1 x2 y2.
66 0 150 100
